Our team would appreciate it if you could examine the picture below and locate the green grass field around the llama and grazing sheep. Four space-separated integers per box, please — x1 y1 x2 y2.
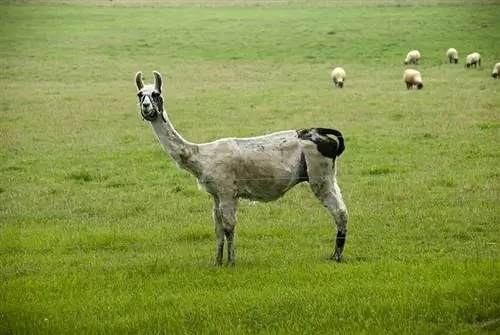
0 0 500 334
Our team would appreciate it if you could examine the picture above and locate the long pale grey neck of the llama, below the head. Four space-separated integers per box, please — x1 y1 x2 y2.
151 111 201 176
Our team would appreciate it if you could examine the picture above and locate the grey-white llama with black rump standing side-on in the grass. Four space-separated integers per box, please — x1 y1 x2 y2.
135 71 348 266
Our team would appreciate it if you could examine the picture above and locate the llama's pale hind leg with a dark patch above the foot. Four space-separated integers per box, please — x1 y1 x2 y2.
311 180 349 262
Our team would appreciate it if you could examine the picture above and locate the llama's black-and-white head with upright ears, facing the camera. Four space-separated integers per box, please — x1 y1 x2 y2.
135 71 163 121
